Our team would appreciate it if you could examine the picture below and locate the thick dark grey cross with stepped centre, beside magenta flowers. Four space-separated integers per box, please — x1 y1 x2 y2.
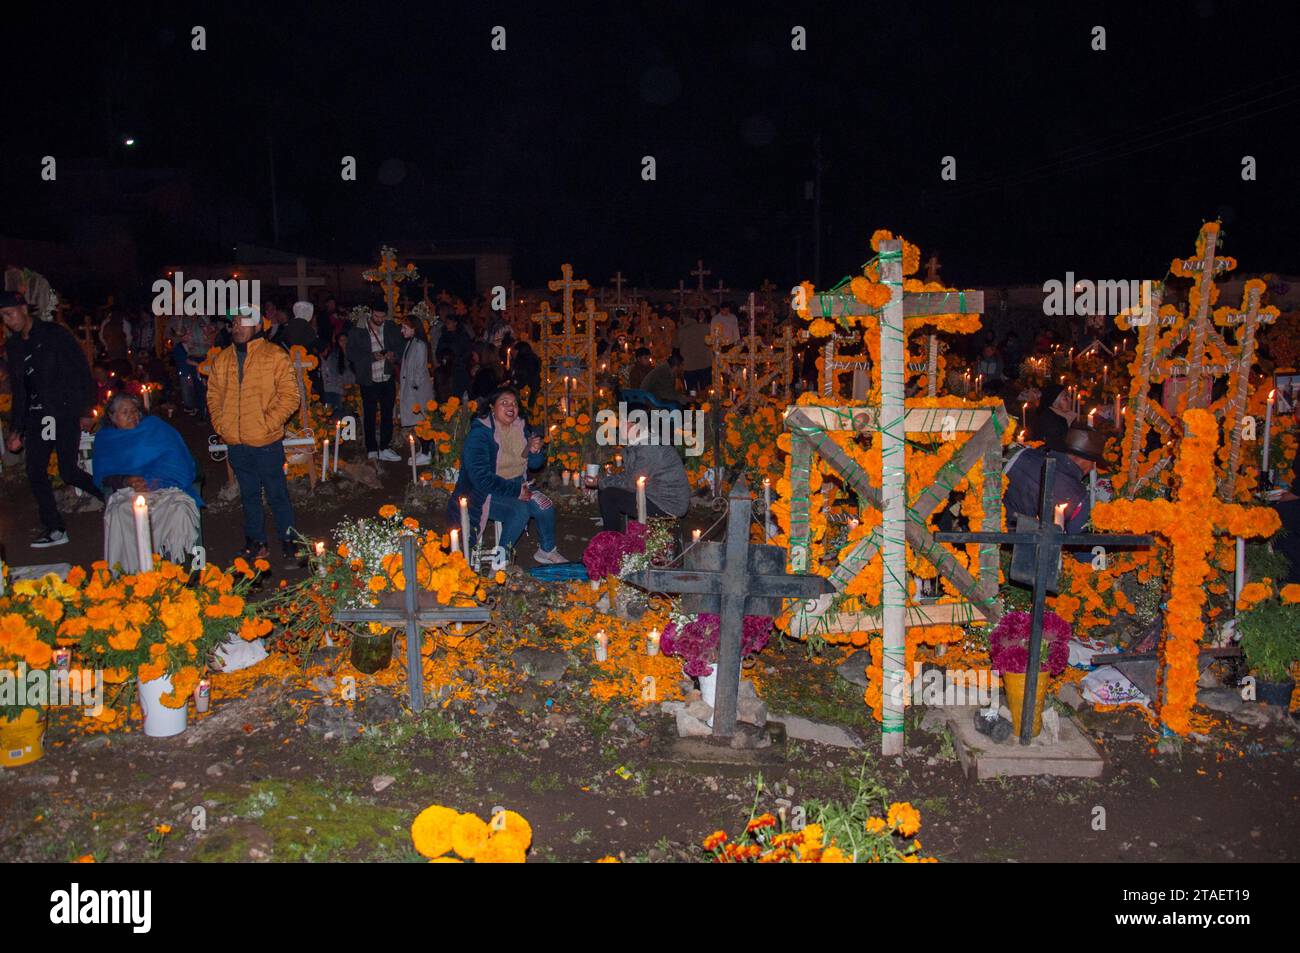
625 477 829 738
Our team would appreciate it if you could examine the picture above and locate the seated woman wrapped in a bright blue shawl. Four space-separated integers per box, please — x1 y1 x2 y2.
92 393 203 573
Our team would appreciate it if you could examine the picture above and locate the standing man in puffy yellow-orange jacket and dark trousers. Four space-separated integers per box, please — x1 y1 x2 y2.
208 308 298 560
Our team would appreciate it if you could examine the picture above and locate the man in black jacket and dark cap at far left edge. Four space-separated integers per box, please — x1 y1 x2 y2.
0 291 104 549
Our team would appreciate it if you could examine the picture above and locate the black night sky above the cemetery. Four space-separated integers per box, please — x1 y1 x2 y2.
0 0 1300 287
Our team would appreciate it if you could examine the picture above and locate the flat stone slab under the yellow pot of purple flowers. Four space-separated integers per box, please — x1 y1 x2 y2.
940 706 1105 781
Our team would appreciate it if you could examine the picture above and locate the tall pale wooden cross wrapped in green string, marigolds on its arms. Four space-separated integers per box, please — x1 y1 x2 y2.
790 238 982 755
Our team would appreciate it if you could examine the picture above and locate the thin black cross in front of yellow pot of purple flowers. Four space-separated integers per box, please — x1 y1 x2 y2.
935 455 1154 745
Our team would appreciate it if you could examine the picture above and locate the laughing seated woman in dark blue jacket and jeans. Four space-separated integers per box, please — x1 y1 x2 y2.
447 387 568 563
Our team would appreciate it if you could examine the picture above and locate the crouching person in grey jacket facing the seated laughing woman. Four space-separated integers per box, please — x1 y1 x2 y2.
588 407 690 533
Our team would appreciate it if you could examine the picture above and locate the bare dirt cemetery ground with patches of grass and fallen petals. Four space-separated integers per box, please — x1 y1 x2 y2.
0 419 1300 862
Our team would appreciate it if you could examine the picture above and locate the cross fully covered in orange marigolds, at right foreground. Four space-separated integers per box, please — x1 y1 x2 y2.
1092 408 1281 733
